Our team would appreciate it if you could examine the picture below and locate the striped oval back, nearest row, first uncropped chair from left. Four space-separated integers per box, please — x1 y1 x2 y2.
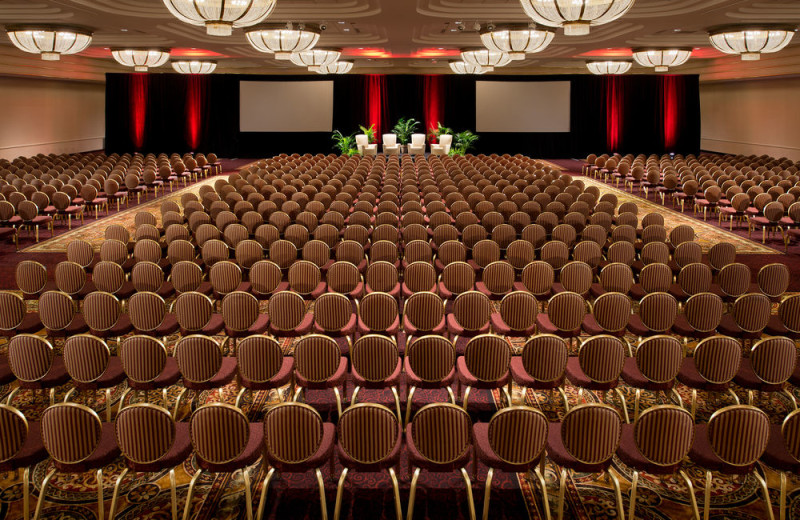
41 403 103 464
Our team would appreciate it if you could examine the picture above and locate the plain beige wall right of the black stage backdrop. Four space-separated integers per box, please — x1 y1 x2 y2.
700 78 800 161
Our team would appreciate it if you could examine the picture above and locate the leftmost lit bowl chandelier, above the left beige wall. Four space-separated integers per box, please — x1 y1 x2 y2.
6 25 92 61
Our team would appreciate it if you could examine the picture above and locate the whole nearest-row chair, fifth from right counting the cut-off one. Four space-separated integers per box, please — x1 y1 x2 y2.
472 406 550 519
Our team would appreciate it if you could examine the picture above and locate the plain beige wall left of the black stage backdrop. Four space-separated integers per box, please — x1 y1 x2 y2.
0 76 105 160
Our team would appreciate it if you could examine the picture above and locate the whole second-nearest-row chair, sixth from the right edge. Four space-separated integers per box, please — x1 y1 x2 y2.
456 334 511 410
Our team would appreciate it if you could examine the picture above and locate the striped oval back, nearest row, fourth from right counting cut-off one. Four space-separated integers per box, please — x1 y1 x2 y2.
561 403 622 464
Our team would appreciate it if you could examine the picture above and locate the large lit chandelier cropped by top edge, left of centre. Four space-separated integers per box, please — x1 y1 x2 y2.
164 0 276 36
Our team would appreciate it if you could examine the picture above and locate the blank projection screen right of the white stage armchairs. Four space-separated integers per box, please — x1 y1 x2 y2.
475 81 571 132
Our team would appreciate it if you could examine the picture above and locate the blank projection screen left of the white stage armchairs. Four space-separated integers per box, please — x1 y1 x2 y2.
239 81 333 132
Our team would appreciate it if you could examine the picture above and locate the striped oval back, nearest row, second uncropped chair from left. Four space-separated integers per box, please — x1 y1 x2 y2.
114 403 176 464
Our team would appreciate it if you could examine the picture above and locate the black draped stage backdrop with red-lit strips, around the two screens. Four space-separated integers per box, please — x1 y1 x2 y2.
106 74 700 158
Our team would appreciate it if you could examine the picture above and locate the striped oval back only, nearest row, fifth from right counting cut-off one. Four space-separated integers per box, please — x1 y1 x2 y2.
489 406 548 464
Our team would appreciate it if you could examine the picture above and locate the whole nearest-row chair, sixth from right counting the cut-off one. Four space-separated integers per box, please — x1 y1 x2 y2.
406 403 475 520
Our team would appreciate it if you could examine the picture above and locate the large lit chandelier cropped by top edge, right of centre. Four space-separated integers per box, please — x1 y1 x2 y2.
520 0 635 36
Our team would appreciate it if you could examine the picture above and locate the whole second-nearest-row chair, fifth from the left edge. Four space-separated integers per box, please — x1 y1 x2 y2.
236 335 294 408
